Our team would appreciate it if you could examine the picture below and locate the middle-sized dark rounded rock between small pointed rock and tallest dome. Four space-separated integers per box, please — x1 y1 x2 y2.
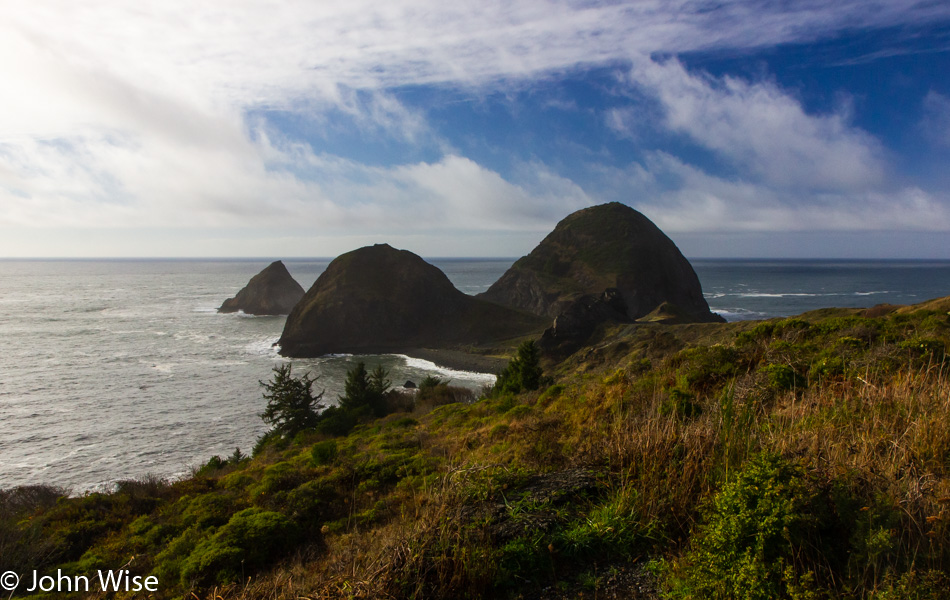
278 244 547 357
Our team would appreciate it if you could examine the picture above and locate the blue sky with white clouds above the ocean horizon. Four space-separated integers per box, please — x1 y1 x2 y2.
0 0 950 259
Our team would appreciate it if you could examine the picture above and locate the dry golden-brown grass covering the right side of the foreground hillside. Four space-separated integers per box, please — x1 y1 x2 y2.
192 352 950 600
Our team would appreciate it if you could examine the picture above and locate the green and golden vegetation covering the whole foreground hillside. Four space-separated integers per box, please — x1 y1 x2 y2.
0 307 950 600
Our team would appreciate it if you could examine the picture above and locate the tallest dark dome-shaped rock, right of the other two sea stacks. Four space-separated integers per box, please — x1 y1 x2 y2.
480 202 723 322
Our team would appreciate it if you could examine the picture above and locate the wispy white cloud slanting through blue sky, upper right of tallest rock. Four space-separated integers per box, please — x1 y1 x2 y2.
631 59 887 191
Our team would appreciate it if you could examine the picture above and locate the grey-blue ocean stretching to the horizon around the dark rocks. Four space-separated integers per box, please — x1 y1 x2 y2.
0 259 950 493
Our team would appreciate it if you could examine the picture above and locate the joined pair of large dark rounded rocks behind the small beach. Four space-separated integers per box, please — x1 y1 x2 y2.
279 203 724 368
